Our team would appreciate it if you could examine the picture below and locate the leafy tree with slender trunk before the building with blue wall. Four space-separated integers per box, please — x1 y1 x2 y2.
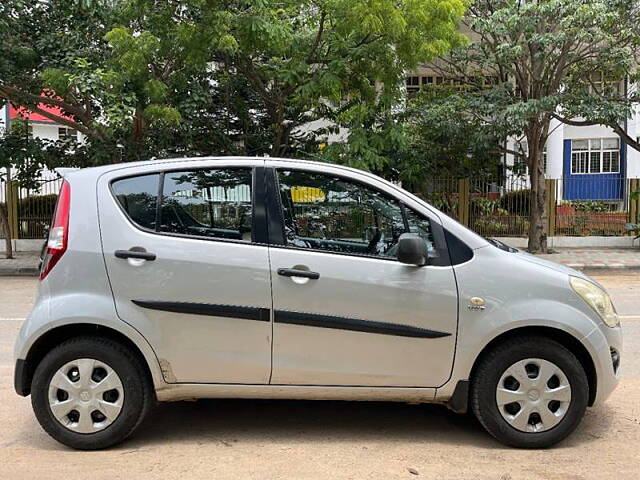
420 0 640 252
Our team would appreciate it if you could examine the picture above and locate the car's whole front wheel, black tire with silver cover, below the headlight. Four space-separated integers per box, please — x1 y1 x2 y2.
471 336 589 448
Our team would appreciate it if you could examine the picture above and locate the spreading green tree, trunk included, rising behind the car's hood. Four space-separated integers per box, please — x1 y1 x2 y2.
415 0 640 251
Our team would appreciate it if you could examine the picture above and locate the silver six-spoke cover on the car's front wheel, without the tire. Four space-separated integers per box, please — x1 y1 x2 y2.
496 358 571 433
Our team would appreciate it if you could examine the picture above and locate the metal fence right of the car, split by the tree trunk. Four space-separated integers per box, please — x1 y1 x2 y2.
417 175 640 237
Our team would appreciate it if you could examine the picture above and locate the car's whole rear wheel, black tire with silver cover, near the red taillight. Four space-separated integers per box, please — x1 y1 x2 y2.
31 336 155 450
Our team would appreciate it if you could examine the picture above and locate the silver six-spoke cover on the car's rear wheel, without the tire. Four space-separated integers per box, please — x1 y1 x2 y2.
49 358 124 433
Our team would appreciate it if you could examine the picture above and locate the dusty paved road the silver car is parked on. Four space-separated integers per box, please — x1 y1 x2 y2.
0 274 640 480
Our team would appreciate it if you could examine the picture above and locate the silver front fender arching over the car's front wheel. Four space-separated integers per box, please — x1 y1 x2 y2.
436 247 606 400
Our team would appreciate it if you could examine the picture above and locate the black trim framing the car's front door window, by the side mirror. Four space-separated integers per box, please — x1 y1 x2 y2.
266 165 451 267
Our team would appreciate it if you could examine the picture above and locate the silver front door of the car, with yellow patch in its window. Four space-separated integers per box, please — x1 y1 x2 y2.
270 166 457 387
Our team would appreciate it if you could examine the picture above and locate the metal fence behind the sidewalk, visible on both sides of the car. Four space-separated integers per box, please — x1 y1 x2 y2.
0 172 640 239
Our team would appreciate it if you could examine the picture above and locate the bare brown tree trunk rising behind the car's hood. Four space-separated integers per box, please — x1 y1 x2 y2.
527 125 549 253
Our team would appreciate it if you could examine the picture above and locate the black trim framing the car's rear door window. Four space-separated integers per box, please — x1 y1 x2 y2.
109 165 269 246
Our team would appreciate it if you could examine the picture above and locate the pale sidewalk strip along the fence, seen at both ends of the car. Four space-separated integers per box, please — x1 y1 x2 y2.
0 248 640 277
